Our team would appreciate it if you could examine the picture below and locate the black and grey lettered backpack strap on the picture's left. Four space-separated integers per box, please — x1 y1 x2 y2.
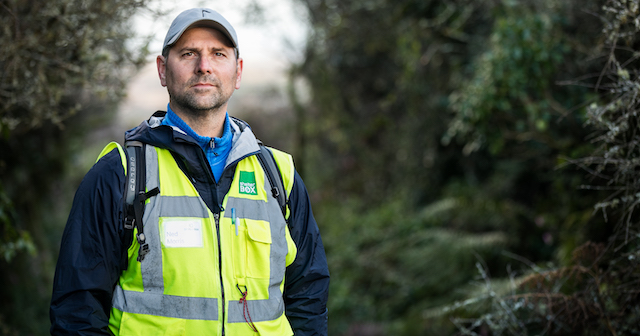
124 141 160 262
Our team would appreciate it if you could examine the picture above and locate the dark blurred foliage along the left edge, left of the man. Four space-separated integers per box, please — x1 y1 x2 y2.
0 0 154 334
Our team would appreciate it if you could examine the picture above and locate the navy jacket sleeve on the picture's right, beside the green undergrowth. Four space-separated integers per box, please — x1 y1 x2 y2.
284 172 329 336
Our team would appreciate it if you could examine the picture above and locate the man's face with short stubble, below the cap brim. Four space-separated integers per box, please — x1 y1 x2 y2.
157 28 242 115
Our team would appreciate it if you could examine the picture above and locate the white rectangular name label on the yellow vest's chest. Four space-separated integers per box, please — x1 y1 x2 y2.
162 218 203 247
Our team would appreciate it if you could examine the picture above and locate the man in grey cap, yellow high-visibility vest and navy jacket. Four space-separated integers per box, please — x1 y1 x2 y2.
50 8 329 335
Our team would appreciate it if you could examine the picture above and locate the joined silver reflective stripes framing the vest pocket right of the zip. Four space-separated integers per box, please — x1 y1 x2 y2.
225 179 288 323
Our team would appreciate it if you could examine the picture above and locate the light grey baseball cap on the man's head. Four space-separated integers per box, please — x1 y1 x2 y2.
162 8 238 53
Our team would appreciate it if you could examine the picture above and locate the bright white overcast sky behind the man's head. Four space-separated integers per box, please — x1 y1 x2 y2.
119 0 307 128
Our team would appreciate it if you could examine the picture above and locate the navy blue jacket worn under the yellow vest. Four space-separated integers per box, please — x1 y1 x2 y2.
50 113 329 336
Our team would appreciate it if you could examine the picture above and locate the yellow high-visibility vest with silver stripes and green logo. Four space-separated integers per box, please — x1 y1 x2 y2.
101 144 296 336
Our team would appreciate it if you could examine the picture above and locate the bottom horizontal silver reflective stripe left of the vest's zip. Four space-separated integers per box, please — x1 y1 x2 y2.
113 284 218 321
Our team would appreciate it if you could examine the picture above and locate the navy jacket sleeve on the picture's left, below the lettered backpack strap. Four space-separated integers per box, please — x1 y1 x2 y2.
49 150 125 335
